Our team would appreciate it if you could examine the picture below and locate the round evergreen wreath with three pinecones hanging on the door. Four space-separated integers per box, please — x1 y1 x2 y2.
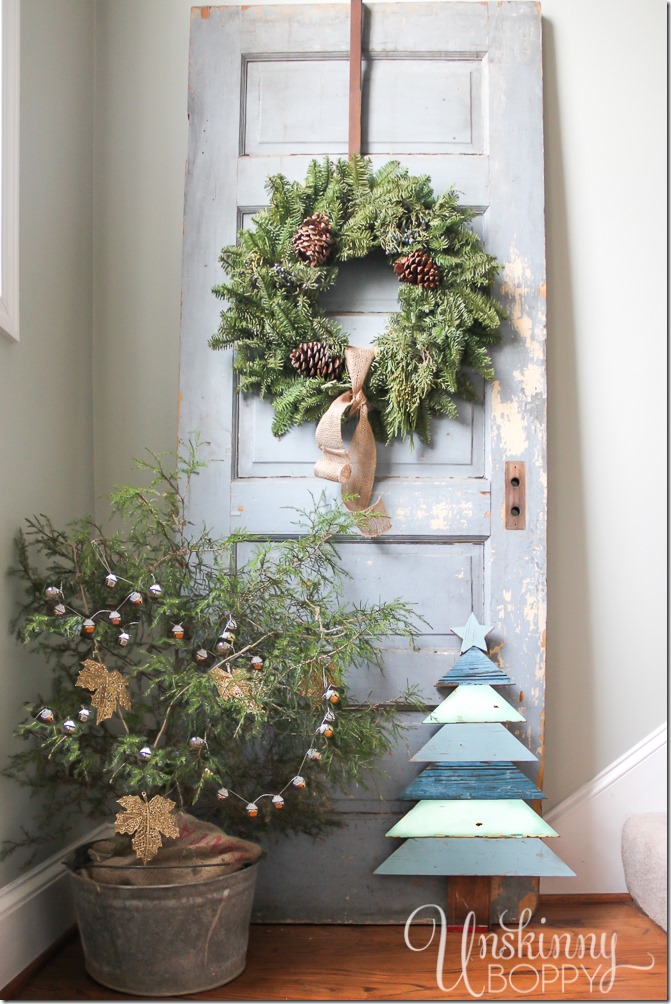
209 156 505 443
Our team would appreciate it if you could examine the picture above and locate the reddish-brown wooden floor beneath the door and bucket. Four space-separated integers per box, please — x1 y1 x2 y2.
4 898 668 1001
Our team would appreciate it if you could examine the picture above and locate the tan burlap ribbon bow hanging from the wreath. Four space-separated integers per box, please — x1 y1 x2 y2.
314 346 392 537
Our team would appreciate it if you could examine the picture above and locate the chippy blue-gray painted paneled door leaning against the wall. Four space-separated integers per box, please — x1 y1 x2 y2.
180 2 545 923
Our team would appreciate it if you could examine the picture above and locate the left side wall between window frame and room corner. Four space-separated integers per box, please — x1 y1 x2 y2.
0 0 94 886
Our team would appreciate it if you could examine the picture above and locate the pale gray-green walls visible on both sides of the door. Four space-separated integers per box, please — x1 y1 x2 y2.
0 0 667 895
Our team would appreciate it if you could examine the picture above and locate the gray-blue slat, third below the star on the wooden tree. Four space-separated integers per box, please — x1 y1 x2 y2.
410 722 537 763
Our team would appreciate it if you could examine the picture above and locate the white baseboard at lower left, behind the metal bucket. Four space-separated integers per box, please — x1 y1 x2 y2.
0 824 109 987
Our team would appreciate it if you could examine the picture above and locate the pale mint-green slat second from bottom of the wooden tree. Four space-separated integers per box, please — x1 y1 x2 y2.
386 798 558 838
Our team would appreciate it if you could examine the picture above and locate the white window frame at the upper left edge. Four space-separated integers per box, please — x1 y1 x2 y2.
0 0 20 341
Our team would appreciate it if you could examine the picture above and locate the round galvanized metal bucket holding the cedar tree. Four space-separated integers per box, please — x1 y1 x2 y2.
65 861 258 997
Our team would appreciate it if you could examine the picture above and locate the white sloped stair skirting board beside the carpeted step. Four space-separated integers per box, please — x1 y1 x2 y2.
540 722 667 894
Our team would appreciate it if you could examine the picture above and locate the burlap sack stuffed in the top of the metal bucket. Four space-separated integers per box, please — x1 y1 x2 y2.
79 812 262 886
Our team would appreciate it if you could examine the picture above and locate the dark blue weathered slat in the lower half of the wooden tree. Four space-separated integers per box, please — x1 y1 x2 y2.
398 760 545 802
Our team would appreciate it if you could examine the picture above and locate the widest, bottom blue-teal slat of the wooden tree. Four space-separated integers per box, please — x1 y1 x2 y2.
375 836 576 879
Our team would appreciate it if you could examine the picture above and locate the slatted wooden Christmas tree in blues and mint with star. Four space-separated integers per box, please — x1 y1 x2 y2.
376 613 574 926
